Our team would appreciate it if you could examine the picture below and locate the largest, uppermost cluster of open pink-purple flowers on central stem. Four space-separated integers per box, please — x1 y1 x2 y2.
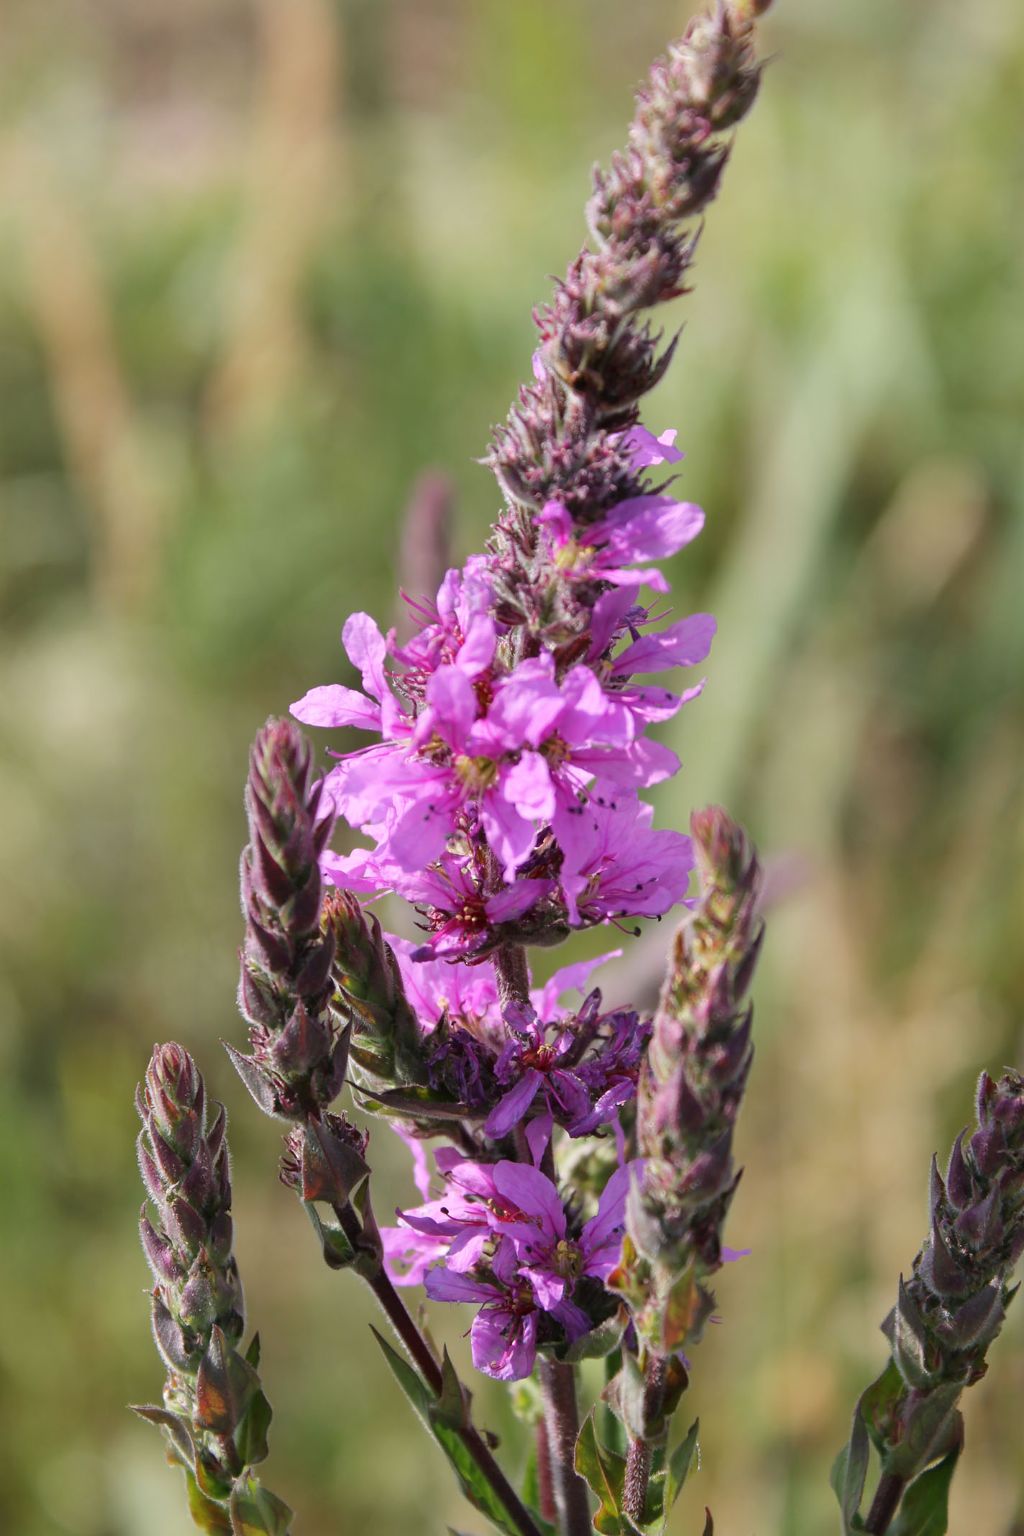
292 430 714 958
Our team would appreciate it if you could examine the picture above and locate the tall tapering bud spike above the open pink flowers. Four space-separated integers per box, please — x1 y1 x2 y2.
488 0 768 648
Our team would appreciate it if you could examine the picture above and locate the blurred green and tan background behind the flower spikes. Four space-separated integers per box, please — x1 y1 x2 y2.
0 0 1024 1536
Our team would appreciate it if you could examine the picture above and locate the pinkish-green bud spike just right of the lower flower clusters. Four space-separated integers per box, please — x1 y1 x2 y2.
622 808 761 1352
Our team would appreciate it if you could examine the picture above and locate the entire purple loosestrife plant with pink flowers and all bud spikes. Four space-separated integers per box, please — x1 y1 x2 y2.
130 0 1024 1536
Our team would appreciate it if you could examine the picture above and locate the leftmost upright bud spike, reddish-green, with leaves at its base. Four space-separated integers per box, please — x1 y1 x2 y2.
137 1044 290 1536
